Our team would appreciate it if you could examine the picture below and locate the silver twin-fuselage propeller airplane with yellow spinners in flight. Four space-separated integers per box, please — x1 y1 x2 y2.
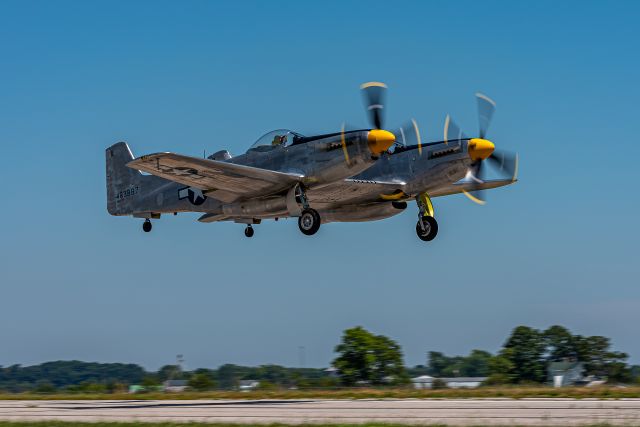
106 83 517 241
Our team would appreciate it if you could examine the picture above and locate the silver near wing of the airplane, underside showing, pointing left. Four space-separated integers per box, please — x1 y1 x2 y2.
127 153 303 203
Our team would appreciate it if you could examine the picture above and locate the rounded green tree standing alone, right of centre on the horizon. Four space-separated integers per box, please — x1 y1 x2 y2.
333 326 407 386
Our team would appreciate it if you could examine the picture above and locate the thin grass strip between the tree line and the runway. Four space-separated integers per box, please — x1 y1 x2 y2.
0 386 640 402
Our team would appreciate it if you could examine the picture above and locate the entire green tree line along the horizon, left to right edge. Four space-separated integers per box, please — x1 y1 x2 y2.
0 325 640 393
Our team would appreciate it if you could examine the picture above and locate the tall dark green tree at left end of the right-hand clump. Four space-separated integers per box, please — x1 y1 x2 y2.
500 326 547 383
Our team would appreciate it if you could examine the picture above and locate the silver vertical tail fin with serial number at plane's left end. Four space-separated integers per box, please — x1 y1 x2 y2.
106 142 143 215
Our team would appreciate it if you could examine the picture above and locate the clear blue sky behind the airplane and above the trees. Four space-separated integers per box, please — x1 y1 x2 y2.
0 1 640 368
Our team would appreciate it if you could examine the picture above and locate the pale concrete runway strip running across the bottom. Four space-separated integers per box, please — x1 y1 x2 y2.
0 399 640 426
